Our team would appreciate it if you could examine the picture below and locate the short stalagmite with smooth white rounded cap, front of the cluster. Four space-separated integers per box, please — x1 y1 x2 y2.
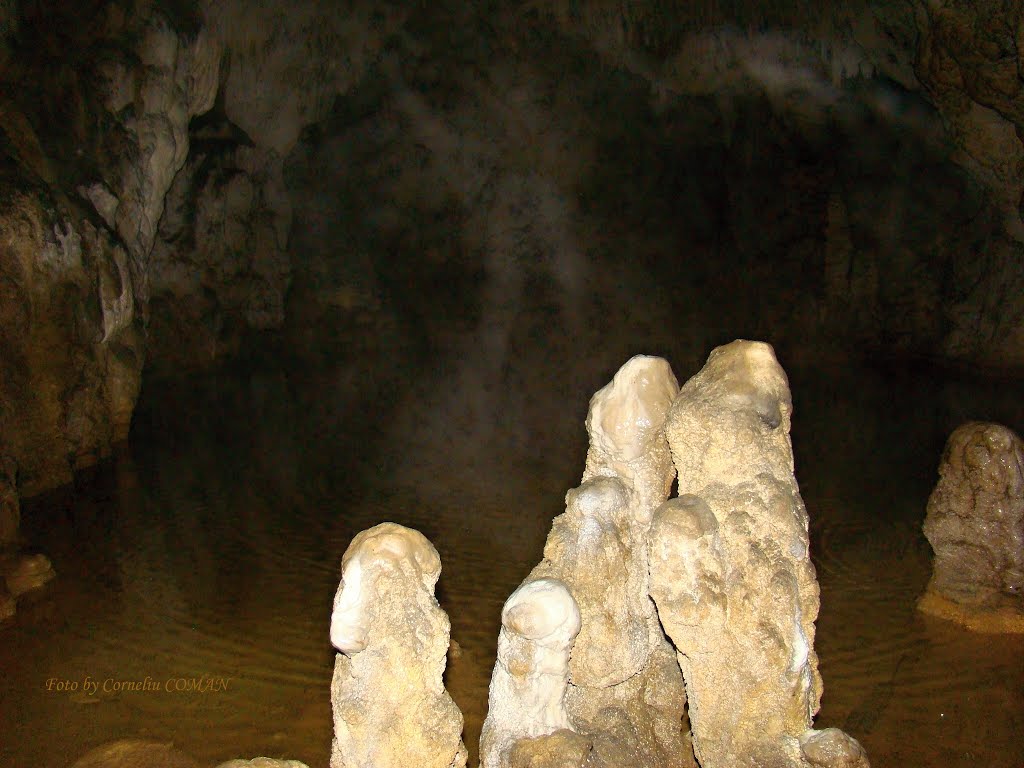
480 579 589 768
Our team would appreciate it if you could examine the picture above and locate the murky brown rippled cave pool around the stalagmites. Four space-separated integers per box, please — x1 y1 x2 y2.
0 367 1024 768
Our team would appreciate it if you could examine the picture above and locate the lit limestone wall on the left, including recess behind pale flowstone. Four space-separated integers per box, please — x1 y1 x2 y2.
0 0 402 495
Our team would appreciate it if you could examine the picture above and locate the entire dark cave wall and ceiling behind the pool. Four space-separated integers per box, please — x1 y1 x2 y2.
0 0 1024 501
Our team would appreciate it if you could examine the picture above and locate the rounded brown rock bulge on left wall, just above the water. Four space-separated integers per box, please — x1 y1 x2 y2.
0 191 145 496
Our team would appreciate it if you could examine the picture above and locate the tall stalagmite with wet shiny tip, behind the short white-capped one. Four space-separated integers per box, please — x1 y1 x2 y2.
481 355 692 768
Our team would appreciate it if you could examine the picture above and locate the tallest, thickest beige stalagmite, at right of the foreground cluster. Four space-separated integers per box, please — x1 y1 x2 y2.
650 341 866 768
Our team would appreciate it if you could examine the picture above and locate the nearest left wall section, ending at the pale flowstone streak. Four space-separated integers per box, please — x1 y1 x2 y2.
0 3 220 495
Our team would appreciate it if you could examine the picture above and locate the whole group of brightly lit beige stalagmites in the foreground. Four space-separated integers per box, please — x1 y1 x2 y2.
331 341 868 768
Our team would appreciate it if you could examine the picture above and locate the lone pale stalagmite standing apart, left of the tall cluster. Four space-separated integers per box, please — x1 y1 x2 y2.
331 522 468 768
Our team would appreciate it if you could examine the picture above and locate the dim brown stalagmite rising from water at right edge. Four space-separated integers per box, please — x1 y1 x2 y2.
918 422 1024 632
